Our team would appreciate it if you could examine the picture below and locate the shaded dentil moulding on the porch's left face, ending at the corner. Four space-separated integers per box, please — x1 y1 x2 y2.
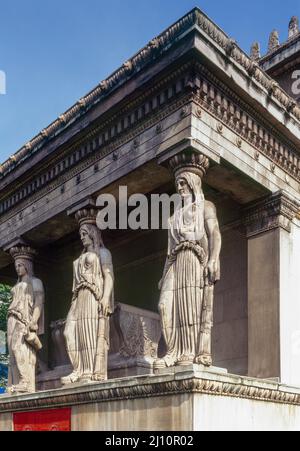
0 70 191 223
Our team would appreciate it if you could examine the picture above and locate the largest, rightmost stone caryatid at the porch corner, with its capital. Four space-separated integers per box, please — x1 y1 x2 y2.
154 153 221 369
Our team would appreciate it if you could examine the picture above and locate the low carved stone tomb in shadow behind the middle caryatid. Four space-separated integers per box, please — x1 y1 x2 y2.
37 303 161 390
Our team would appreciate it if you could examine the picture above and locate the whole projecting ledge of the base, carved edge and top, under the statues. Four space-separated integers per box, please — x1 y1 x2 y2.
0 372 300 414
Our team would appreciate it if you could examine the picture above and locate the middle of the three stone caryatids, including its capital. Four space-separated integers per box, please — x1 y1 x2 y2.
62 208 114 384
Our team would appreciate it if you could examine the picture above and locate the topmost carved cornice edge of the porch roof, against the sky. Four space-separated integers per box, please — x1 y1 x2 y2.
0 8 300 177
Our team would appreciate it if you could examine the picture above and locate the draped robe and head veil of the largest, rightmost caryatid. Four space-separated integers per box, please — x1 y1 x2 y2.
159 170 220 366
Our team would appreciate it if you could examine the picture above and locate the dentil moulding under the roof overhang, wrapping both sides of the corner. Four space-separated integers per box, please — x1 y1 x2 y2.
0 59 300 223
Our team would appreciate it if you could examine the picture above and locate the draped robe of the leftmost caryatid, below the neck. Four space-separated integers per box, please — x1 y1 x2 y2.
7 277 44 391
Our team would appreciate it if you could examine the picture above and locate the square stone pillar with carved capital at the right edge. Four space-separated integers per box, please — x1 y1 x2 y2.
244 192 300 384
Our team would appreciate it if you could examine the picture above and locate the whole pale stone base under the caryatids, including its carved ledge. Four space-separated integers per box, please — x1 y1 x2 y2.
0 365 300 432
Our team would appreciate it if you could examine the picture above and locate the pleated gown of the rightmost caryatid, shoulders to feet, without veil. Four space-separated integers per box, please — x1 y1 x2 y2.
159 200 208 366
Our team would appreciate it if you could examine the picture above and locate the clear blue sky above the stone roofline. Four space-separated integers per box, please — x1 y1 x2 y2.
0 0 300 161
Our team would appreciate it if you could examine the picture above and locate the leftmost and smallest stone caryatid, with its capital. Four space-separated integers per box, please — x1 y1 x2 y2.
7 245 45 393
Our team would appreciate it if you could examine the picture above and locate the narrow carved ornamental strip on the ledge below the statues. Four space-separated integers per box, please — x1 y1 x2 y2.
0 376 300 413
